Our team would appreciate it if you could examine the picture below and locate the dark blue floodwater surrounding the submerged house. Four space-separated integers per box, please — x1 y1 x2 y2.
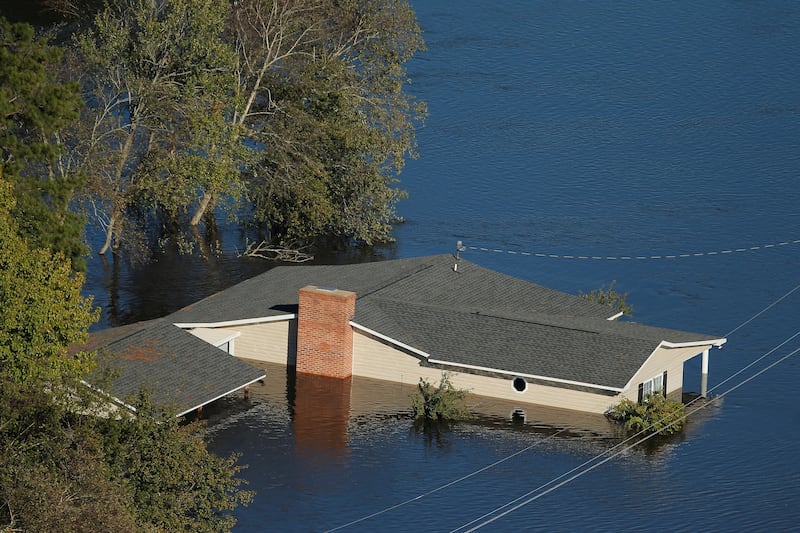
76 0 800 532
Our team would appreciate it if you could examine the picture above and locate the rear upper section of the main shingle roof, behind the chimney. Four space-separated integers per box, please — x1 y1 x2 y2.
169 255 612 323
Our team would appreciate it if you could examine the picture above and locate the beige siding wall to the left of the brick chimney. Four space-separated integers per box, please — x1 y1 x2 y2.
190 319 297 365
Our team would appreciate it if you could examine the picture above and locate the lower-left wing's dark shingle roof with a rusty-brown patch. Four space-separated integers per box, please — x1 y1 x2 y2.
86 319 264 414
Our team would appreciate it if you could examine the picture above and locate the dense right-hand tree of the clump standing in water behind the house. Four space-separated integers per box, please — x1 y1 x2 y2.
242 0 426 244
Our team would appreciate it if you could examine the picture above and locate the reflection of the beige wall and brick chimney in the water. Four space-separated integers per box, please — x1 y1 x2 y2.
204 361 709 462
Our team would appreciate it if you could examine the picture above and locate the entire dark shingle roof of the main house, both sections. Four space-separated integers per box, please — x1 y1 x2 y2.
162 251 718 388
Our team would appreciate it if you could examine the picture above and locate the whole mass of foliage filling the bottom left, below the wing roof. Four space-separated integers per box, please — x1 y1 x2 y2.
0 383 252 532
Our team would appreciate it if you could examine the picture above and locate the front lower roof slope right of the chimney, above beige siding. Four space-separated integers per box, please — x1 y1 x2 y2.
358 299 714 389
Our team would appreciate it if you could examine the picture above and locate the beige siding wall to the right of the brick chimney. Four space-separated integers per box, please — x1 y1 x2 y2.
353 330 617 413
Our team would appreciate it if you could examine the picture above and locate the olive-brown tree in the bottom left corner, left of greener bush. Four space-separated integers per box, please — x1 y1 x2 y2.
0 381 142 532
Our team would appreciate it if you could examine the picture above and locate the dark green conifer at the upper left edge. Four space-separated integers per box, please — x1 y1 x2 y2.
0 19 86 269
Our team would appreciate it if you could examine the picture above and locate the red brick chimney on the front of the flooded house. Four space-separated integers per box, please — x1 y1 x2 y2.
296 285 356 378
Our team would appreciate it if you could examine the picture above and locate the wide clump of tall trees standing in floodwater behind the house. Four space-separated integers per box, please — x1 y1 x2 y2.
57 0 425 253
